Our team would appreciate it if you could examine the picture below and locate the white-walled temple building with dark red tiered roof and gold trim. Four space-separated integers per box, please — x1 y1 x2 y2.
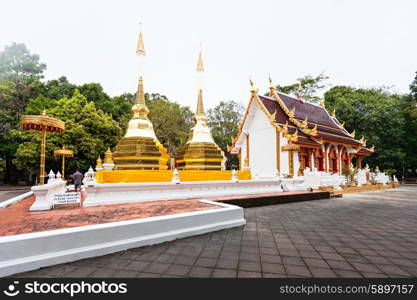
229 79 373 177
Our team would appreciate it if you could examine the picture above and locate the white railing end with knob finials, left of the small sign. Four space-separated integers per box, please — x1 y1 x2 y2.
30 170 67 210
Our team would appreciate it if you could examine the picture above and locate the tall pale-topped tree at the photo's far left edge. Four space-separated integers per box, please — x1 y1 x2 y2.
0 43 46 183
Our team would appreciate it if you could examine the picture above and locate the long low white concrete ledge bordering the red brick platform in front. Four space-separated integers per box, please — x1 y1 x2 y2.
0 200 246 276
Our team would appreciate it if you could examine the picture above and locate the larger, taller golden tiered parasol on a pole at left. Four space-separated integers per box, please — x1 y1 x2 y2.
20 110 65 185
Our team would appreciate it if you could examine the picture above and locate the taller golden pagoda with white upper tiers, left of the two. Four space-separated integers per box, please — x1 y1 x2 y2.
113 32 169 170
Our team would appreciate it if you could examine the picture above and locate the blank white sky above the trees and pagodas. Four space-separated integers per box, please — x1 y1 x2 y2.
0 0 417 109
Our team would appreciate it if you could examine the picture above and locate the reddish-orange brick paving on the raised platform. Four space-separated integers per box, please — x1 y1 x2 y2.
0 196 219 237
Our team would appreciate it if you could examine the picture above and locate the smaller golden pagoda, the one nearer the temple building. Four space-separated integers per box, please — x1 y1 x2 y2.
176 51 226 171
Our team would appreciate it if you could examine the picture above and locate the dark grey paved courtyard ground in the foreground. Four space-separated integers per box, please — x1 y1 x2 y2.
12 186 417 277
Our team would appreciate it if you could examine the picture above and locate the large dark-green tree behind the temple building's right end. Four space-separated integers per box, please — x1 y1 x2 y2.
324 86 408 176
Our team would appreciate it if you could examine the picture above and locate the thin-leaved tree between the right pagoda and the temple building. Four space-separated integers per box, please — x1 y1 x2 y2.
207 101 244 169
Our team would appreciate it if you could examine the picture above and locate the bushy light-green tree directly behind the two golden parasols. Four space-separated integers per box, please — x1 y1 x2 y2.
13 89 121 183
